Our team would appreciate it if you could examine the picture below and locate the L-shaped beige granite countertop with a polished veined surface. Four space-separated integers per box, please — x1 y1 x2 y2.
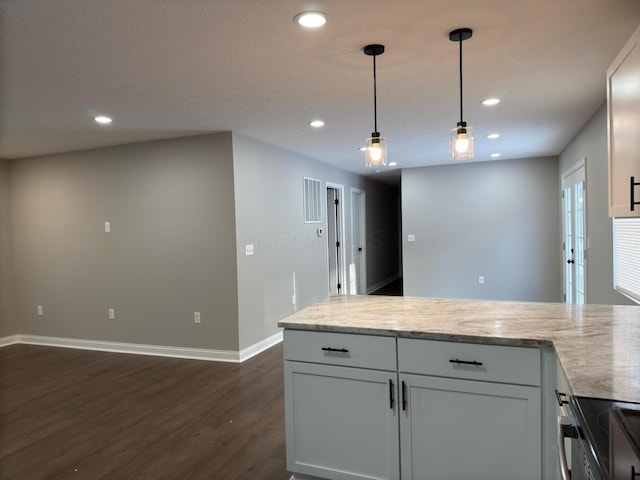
278 295 640 402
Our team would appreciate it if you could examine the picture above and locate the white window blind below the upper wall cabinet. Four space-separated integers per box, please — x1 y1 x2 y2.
613 218 640 303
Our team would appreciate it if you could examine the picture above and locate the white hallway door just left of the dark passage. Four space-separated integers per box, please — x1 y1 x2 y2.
349 188 367 295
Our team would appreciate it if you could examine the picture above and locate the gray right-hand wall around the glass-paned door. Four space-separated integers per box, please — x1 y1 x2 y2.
558 102 635 305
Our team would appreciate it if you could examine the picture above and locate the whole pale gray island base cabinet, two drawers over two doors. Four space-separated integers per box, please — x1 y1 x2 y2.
284 330 542 480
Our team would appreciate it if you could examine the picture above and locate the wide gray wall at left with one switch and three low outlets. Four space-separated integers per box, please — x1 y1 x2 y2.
11 133 238 350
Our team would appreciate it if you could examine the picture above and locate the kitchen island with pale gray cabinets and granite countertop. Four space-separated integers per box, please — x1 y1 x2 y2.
279 296 640 480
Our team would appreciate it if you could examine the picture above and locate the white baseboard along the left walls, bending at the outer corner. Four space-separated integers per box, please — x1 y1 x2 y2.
0 331 282 363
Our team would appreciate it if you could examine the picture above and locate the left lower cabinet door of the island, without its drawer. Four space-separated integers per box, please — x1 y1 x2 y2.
284 361 400 480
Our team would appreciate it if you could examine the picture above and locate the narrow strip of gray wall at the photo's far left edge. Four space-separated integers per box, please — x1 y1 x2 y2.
0 159 18 337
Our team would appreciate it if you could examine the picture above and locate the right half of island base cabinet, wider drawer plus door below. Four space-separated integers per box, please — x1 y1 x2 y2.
398 338 542 480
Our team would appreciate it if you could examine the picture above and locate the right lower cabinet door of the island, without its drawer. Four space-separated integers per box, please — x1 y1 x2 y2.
400 375 542 480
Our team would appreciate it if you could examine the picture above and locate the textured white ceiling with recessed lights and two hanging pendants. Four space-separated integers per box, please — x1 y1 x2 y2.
0 0 640 184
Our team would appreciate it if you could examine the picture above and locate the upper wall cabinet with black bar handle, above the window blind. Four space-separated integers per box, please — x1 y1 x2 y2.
607 23 640 217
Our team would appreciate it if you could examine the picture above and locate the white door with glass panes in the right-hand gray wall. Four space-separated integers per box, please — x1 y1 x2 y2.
562 158 587 304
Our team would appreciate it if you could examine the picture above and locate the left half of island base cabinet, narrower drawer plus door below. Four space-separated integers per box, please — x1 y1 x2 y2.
285 330 400 480
